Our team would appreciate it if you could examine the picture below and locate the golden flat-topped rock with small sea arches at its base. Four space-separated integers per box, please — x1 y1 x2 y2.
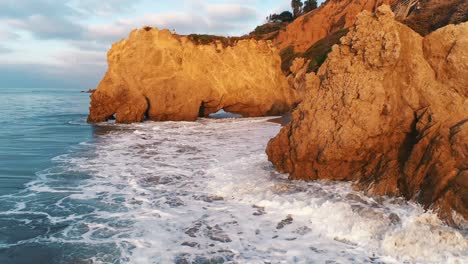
88 28 296 123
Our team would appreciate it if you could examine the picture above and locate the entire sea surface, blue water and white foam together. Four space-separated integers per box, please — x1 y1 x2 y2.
0 89 468 264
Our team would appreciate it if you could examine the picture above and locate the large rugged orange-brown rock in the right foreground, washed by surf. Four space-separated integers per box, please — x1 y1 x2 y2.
267 5 468 224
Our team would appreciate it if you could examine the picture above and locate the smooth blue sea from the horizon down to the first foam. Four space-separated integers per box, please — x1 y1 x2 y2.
0 88 93 195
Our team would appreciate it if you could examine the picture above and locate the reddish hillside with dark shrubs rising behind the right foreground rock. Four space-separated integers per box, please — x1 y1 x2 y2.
272 0 468 73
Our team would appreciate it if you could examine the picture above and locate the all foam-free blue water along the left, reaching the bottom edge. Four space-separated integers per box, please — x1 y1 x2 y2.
0 88 95 263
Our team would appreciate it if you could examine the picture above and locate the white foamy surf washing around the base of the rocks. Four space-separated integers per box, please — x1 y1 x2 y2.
4 118 468 263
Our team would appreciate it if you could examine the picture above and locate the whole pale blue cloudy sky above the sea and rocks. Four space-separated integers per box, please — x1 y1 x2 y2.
0 0 322 90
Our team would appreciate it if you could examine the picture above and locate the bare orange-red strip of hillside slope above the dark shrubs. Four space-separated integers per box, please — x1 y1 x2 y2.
274 0 396 52
